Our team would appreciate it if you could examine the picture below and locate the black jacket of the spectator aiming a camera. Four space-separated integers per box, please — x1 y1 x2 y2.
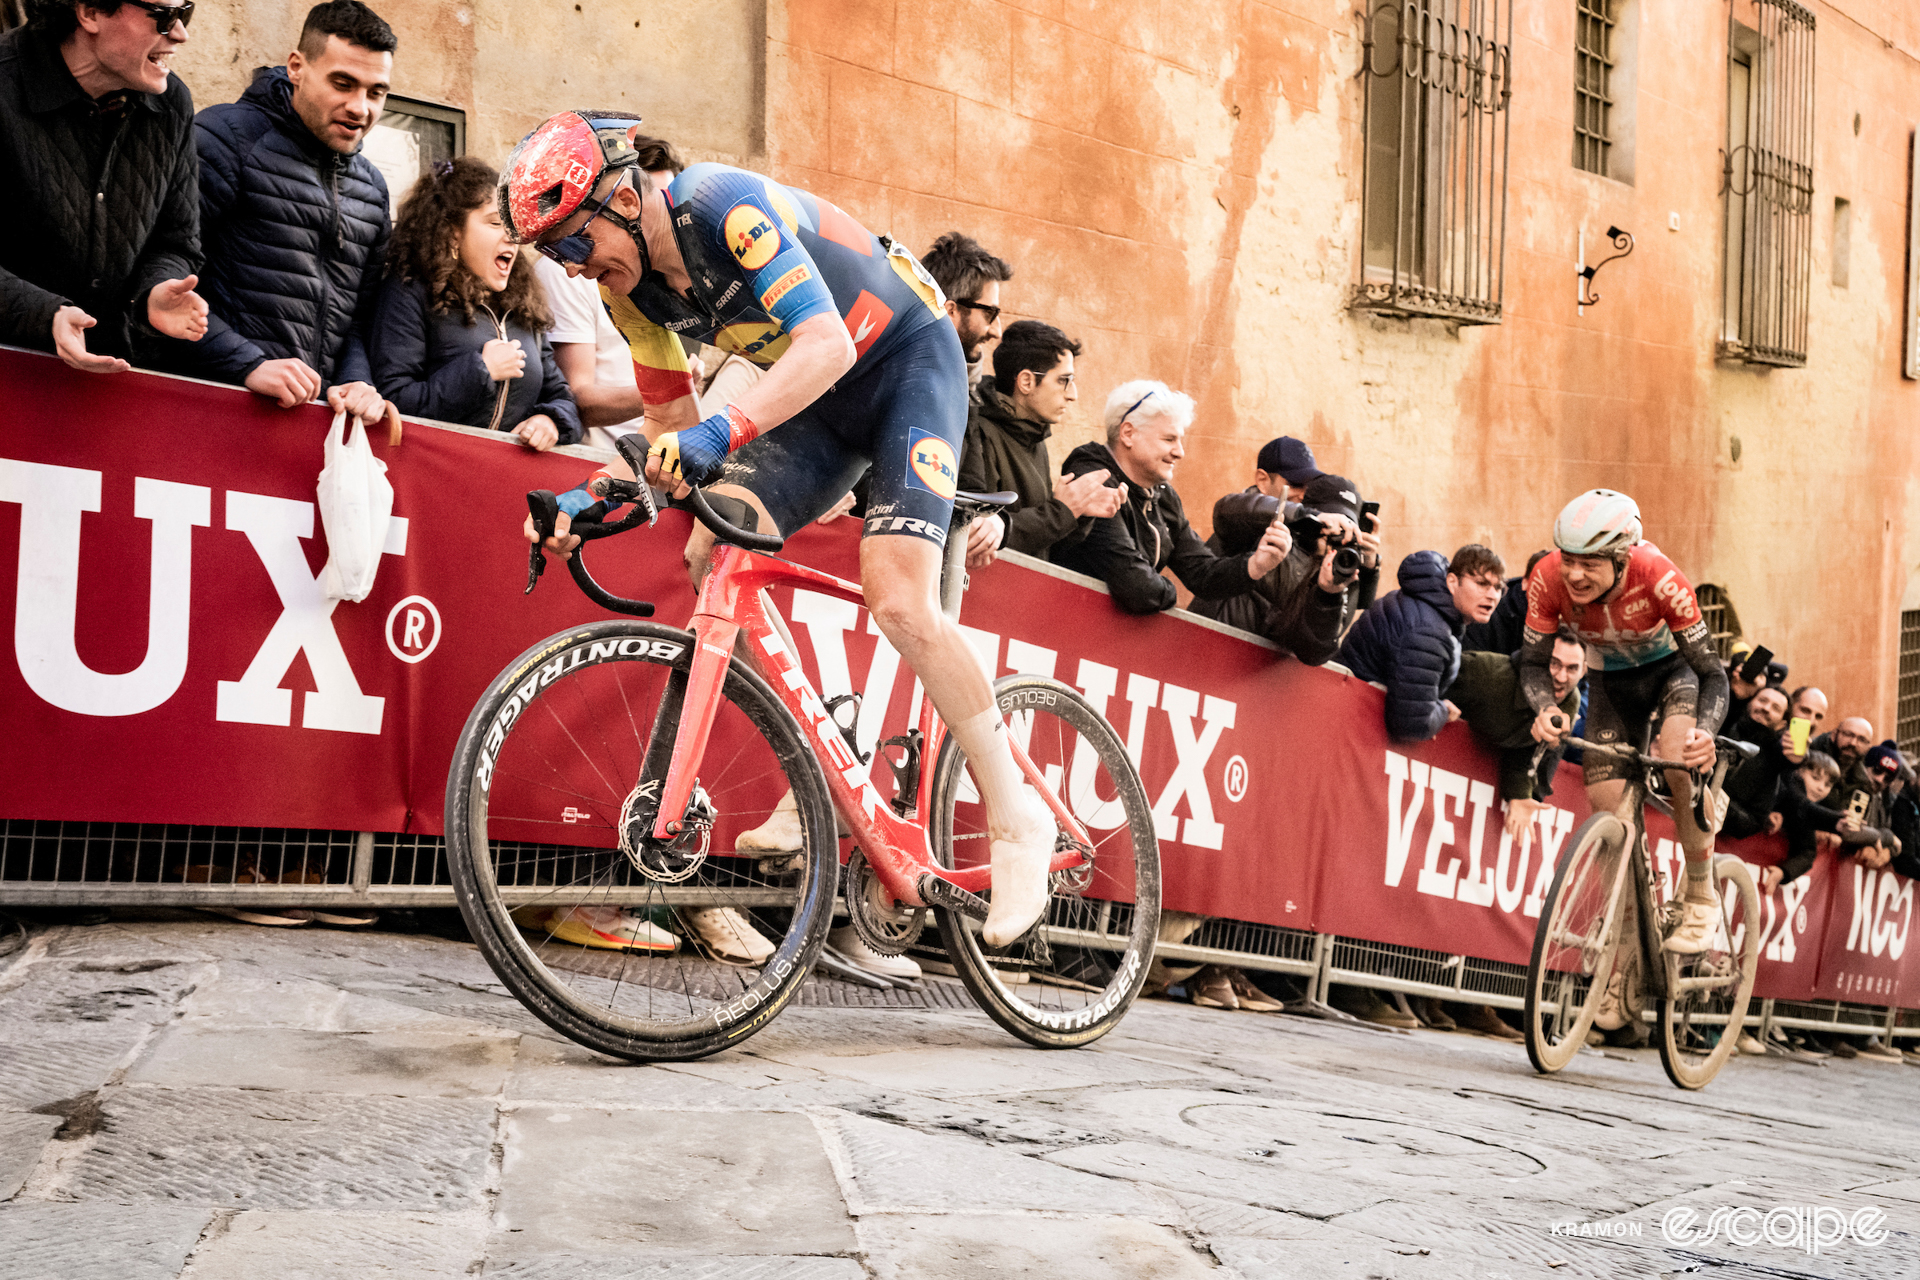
1192 489 1380 666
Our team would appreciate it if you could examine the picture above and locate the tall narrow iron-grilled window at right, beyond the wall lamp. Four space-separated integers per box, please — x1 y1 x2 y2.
1720 0 1814 367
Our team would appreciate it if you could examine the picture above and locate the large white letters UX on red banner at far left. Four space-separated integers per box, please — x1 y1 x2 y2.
0 459 407 733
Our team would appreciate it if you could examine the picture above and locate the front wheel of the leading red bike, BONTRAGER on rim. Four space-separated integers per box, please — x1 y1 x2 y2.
445 622 839 1061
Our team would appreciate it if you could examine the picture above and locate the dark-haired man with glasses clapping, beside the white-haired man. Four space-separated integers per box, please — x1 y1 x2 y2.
960 320 1121 566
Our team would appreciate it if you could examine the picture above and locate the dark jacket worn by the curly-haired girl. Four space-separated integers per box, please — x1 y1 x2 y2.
369 276 580 445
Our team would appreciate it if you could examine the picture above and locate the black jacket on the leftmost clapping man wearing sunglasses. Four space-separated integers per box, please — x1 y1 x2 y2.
0 27 200 357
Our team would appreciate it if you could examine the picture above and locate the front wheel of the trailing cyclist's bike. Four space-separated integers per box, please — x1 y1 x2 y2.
1524 814 1628 1073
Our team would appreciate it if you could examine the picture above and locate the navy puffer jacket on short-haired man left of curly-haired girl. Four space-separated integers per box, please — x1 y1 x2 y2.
169 67 388 386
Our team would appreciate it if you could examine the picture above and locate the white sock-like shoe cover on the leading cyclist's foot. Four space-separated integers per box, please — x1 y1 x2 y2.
947 708 1054 946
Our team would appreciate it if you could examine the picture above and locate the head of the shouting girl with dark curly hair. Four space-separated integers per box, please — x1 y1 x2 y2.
386 155 553 334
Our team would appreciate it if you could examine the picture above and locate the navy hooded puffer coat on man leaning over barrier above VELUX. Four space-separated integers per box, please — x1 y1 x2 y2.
1340 551 1465 743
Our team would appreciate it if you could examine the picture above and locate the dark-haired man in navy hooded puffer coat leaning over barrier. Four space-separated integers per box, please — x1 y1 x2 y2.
1340 543 1507 743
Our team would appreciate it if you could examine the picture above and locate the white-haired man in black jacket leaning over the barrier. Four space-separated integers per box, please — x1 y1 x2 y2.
1050 378 1288 614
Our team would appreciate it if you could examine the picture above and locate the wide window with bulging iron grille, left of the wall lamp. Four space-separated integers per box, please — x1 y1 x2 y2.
1352 0 1513 324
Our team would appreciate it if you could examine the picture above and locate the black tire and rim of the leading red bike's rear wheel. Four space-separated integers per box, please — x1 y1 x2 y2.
927 676 1160 1050
